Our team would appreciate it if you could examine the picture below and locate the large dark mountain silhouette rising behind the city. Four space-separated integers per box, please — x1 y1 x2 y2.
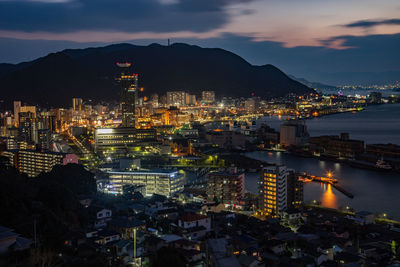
0 44 312 107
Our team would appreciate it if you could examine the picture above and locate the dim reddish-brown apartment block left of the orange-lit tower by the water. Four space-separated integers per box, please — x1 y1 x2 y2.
207 168 244 204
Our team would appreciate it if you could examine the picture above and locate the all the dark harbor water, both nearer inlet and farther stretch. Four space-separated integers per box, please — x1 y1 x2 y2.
245 104 400 219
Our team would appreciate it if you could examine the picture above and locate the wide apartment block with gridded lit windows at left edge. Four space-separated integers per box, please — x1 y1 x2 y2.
3 150 78 177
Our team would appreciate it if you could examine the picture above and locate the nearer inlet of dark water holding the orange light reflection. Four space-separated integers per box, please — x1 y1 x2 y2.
245 151 400 220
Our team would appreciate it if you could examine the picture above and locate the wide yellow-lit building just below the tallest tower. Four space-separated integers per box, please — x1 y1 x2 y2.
94 127 157 157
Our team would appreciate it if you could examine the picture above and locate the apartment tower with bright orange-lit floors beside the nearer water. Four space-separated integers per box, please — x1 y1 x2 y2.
259 166 289 216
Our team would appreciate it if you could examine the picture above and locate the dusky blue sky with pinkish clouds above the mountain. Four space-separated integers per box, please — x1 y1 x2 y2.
0 0 400 84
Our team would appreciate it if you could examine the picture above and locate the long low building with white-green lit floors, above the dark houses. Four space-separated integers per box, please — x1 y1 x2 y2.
106 170 185 197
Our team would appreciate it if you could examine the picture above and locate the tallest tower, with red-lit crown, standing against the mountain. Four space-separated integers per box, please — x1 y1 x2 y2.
117 62 138 127
